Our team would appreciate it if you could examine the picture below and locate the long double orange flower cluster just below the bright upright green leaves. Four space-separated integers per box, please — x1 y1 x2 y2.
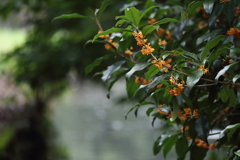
132 32 155 55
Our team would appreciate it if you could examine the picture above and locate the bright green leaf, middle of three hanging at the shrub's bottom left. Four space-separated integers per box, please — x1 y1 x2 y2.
163 134 178 158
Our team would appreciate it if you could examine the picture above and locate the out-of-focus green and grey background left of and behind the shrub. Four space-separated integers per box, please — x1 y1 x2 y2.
0 0 229 160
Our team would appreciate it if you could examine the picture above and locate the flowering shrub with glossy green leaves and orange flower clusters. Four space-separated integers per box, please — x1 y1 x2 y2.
54 0 240 160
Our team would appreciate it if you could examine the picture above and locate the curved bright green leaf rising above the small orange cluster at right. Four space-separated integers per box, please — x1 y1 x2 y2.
200 35 226 62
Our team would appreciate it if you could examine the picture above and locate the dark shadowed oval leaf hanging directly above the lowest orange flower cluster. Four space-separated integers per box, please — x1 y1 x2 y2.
195 114 209 143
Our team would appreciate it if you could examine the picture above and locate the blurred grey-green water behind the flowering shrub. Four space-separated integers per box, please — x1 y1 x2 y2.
52 81 171 160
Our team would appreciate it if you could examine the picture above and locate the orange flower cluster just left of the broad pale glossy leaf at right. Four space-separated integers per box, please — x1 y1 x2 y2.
168 76 185 96
